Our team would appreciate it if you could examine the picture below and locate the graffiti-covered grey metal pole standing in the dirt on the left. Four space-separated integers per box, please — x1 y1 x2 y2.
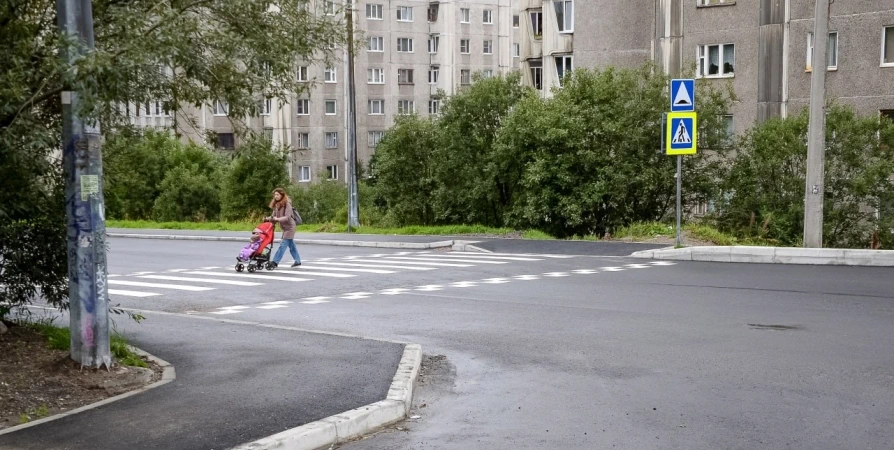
56 0 112 368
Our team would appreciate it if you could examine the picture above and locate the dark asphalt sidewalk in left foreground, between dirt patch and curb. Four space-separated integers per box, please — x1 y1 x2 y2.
0 313 403 450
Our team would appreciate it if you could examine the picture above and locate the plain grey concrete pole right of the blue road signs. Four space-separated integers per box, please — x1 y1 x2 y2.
804 0 829 248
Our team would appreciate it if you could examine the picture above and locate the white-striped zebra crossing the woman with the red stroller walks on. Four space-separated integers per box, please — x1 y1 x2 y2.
109 251 574 298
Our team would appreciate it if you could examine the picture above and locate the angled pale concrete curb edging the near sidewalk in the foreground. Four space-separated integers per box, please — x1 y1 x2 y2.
232 344 422 450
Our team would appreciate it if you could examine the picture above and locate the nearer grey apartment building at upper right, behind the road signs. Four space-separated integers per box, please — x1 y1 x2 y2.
519 0 894 133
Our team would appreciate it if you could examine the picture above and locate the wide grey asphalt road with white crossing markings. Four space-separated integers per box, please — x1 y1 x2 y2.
17 239 894 449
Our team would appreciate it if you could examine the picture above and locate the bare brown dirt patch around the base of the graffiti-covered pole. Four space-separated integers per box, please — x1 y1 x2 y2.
0 325 162 429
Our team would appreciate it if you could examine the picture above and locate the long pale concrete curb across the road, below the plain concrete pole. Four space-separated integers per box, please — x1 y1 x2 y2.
630 246 894 267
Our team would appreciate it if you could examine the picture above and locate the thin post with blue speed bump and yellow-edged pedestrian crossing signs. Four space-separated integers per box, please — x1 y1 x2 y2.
663 79 698 247
